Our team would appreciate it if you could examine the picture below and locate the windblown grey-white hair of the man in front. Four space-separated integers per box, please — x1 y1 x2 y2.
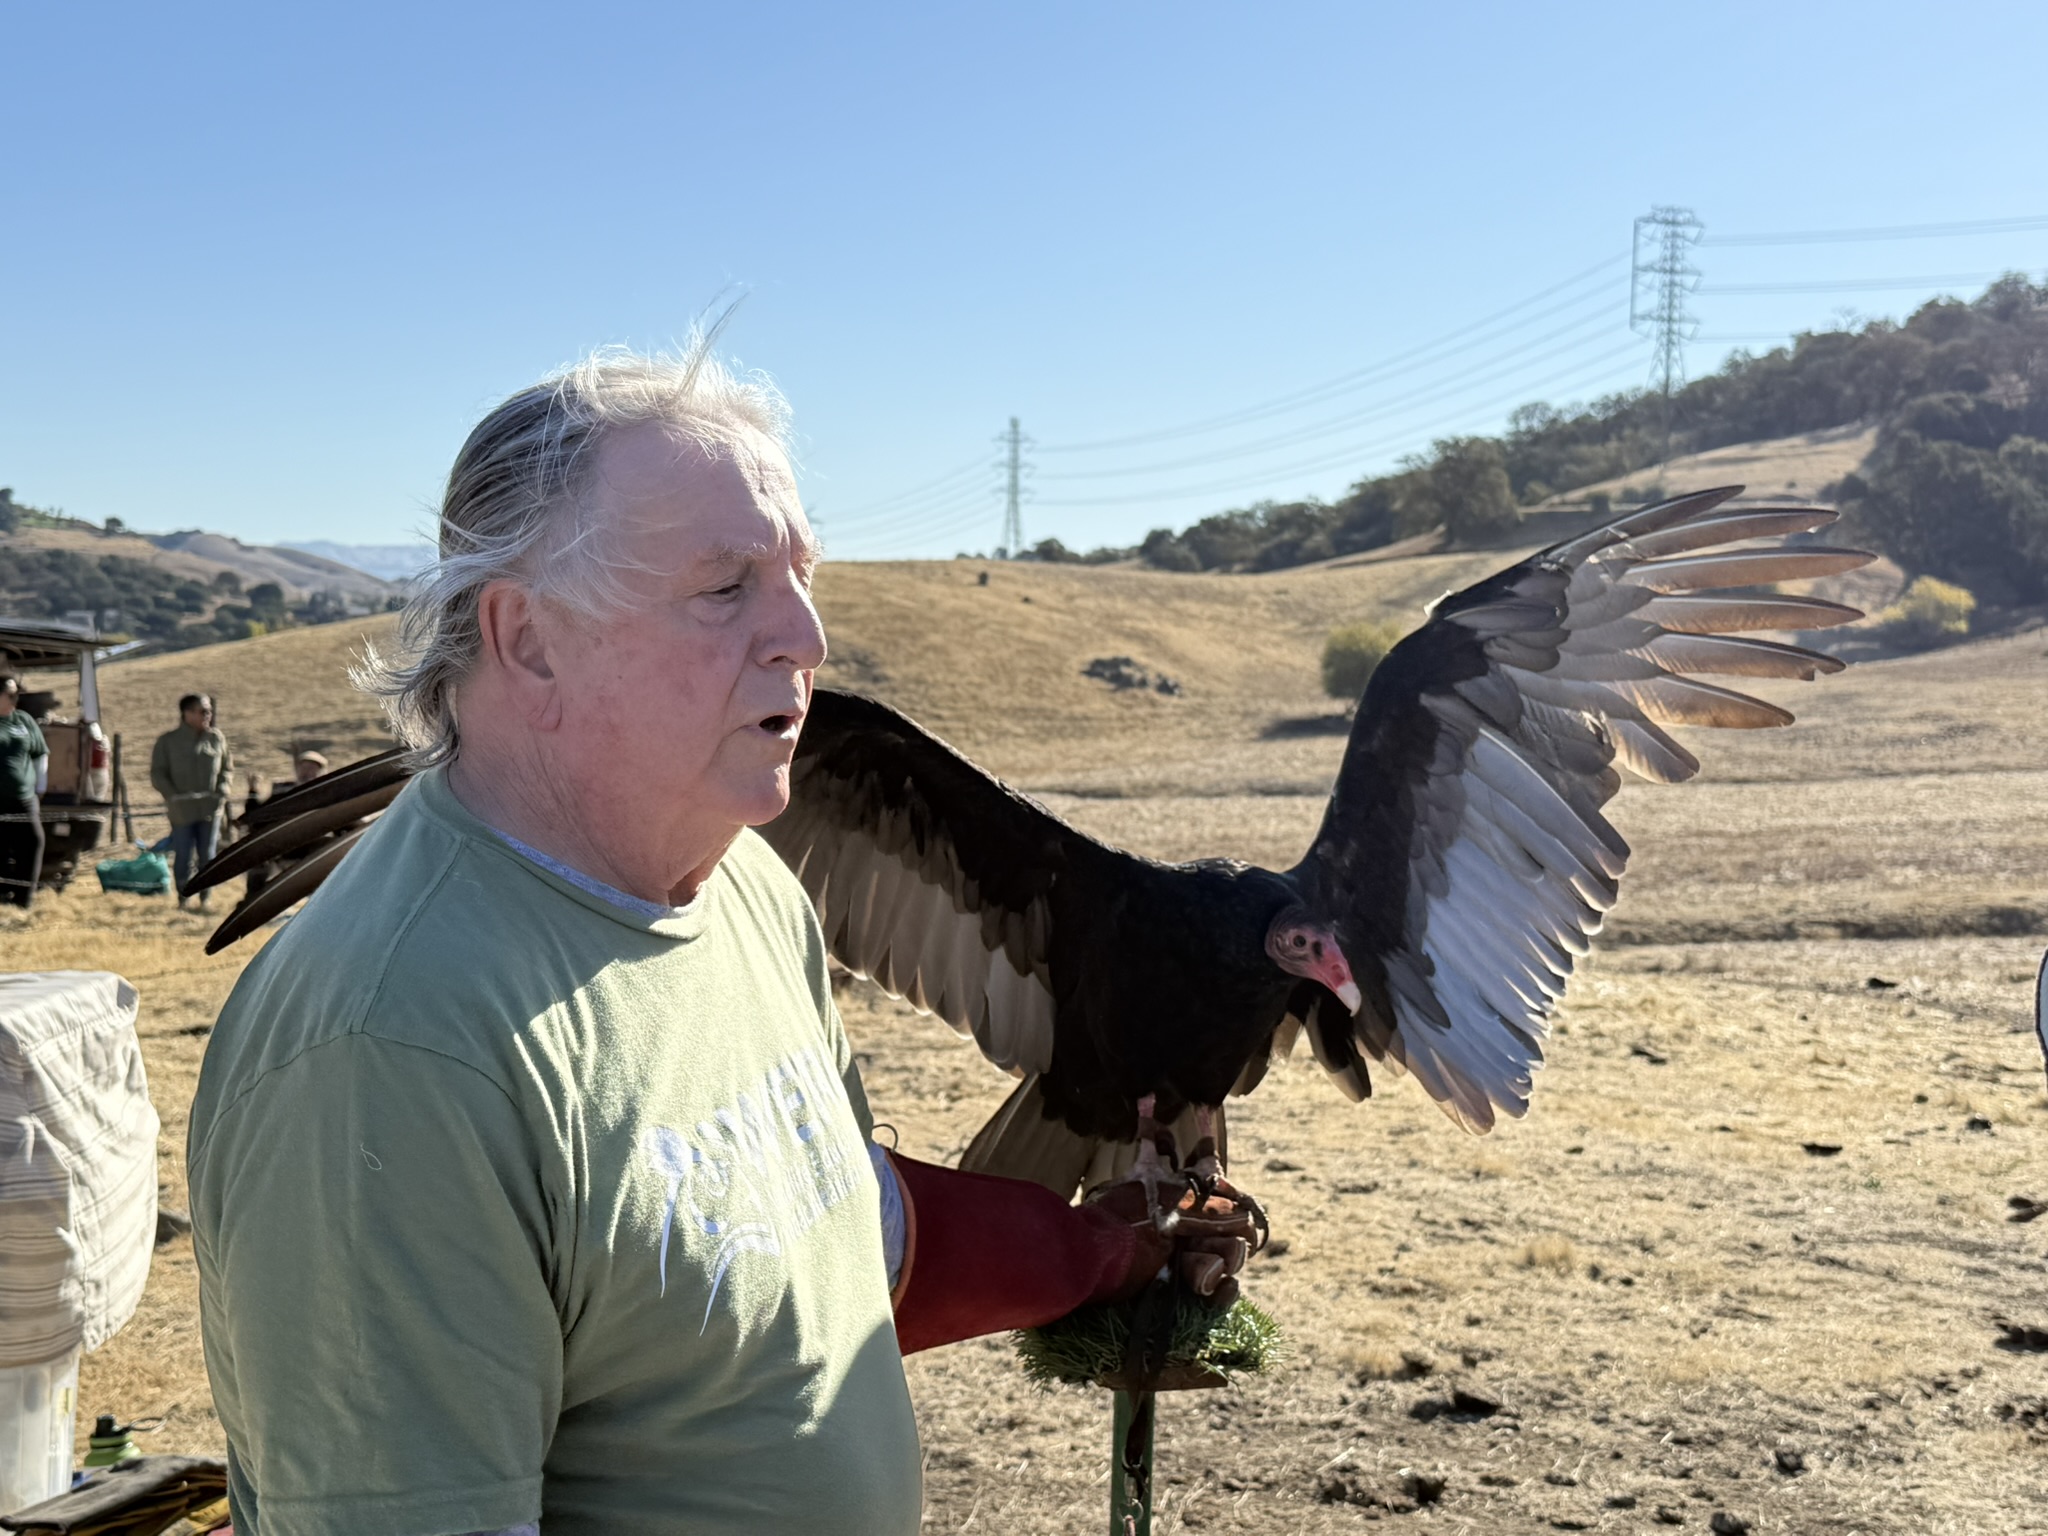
354 342 788 766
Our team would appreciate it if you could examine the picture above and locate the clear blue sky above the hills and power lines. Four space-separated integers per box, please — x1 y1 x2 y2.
0 0 2048 557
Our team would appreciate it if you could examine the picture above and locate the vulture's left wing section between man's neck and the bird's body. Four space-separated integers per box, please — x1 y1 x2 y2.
760 688 1110 1073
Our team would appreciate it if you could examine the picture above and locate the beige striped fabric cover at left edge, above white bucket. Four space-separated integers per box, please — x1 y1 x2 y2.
0 971 158 1368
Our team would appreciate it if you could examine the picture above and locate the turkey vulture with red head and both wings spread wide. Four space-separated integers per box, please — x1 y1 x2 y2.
188 487 1870 1194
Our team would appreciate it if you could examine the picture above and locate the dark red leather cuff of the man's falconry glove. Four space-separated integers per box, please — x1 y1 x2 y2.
889 1153 1139 1354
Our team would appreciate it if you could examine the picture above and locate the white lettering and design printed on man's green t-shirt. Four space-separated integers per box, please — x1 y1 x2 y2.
643 1047 872 1335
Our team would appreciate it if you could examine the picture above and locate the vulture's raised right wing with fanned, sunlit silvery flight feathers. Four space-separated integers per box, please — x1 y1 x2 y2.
1296 487 1870 1130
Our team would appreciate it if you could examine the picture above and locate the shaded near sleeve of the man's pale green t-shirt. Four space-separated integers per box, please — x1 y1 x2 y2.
193 1034 563 1536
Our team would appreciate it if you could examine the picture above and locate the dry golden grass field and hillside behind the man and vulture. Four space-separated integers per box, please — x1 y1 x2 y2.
0 555 2048 1536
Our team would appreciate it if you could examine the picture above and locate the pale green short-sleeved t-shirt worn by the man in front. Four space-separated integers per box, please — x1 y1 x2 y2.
186 770 922 1536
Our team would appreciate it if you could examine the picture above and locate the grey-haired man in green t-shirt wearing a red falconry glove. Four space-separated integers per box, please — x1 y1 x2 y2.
188 354 1236 1536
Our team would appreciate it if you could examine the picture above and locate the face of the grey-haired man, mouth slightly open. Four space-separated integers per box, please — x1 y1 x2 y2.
545 424 825 884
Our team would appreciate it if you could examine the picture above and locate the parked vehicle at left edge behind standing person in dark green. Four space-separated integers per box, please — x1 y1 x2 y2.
0 618 115 891
